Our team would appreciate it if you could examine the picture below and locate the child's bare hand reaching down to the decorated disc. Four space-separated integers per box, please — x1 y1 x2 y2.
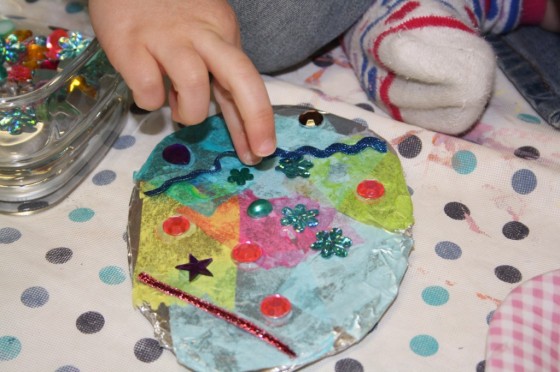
89 0 276 164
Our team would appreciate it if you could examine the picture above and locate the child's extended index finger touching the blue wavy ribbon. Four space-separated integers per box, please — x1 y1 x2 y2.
194 34 276 157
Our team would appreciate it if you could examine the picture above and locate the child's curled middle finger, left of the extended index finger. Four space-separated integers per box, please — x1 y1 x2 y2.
158 48 210 125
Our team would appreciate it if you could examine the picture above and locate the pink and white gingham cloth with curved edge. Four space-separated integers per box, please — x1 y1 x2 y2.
486 270 560 372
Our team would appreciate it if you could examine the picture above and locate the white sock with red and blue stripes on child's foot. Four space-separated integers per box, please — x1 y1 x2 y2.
344 0 520 134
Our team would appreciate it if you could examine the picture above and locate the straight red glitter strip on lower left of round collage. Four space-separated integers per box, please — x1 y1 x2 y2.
138 273 297 358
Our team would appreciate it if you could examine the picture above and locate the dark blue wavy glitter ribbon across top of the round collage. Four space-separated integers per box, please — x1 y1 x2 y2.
144 137 387 196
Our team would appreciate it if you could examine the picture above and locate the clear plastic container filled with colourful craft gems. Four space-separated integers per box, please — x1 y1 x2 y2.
0 18 130 214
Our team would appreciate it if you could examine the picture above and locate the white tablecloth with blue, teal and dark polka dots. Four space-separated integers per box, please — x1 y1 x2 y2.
0 0 560 372
